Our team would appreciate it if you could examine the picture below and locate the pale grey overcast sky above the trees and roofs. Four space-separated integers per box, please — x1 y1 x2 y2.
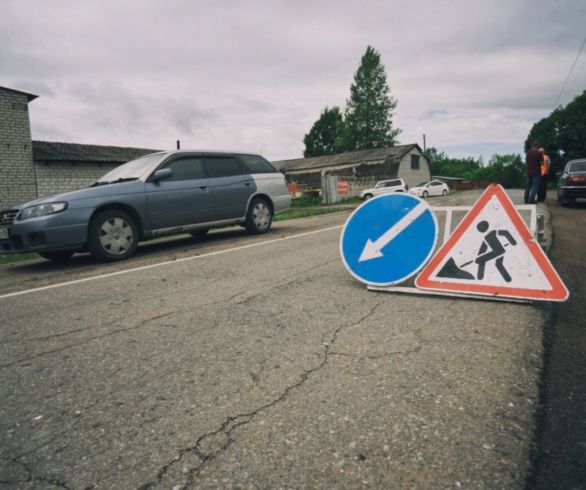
0 0 586 160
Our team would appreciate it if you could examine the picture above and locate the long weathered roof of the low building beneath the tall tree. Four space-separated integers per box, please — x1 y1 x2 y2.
273 143 421 173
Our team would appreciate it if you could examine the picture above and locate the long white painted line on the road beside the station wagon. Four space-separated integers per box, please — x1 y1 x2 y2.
0 225 344 300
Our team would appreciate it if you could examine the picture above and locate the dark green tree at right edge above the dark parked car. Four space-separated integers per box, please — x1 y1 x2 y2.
525 90 586 172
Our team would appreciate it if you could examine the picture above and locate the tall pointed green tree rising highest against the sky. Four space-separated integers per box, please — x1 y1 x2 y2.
336 46 401 151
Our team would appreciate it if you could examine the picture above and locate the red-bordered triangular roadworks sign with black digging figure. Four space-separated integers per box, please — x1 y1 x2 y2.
415 184 569 301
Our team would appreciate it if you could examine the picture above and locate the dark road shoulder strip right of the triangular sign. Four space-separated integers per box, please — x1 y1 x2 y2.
529 197 586 490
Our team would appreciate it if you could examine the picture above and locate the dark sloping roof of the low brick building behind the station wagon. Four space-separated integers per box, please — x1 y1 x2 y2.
33 141 160 163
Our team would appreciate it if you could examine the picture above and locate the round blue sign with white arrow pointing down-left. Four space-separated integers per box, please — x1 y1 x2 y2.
340 193 438 286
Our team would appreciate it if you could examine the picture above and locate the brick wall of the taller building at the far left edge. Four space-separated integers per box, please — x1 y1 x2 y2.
0 89 37 209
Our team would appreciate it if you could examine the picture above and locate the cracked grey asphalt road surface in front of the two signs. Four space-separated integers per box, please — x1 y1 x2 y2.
0 193 550 490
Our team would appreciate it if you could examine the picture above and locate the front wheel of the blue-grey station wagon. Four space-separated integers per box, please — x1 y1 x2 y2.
88 209 138 262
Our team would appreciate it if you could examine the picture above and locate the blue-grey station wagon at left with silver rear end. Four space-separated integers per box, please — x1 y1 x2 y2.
0 150 291 261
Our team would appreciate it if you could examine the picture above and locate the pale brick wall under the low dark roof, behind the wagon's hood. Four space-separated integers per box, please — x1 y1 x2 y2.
35 161 119 197
